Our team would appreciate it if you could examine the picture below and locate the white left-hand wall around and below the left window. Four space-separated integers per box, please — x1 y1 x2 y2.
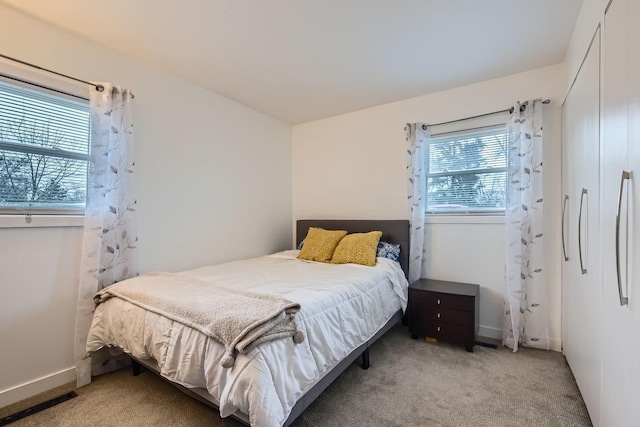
0 4 292 407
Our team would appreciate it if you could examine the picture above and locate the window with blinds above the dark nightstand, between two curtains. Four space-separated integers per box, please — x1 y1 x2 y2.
427 125 507 214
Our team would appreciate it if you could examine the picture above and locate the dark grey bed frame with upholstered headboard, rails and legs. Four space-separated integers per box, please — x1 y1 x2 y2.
131 219 409 426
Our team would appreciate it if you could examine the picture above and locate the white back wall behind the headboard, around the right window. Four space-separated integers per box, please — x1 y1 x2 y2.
293 64 566 350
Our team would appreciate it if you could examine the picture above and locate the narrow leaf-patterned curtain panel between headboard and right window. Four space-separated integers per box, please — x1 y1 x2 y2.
404 123 431 283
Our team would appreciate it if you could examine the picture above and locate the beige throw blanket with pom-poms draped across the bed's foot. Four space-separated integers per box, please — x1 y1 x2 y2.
94 272 304 368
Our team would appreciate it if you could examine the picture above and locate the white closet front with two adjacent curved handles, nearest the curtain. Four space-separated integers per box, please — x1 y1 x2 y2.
562 29 602 425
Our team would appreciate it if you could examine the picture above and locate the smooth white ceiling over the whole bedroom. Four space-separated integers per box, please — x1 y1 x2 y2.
0 0 582 124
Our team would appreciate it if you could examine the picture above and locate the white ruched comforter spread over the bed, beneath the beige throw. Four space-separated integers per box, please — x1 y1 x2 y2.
87 251 407 426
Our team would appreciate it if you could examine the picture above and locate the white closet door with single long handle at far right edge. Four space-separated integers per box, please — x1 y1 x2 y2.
602 0 640 427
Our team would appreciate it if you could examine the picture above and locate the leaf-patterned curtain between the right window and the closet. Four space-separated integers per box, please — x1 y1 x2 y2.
502 99 549 352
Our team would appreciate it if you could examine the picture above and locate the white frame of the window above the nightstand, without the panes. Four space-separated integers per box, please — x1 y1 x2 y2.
425 120 508 217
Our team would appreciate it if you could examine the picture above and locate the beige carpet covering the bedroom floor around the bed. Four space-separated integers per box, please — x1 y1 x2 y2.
0 327 591 427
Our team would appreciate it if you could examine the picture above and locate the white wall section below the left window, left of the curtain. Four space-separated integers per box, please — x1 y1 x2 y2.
0 227 82 407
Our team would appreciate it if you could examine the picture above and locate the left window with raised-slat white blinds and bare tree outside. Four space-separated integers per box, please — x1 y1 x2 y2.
0 78 90 213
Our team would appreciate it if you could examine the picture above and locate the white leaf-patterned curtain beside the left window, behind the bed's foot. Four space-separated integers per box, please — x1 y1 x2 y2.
75 83 138 387
